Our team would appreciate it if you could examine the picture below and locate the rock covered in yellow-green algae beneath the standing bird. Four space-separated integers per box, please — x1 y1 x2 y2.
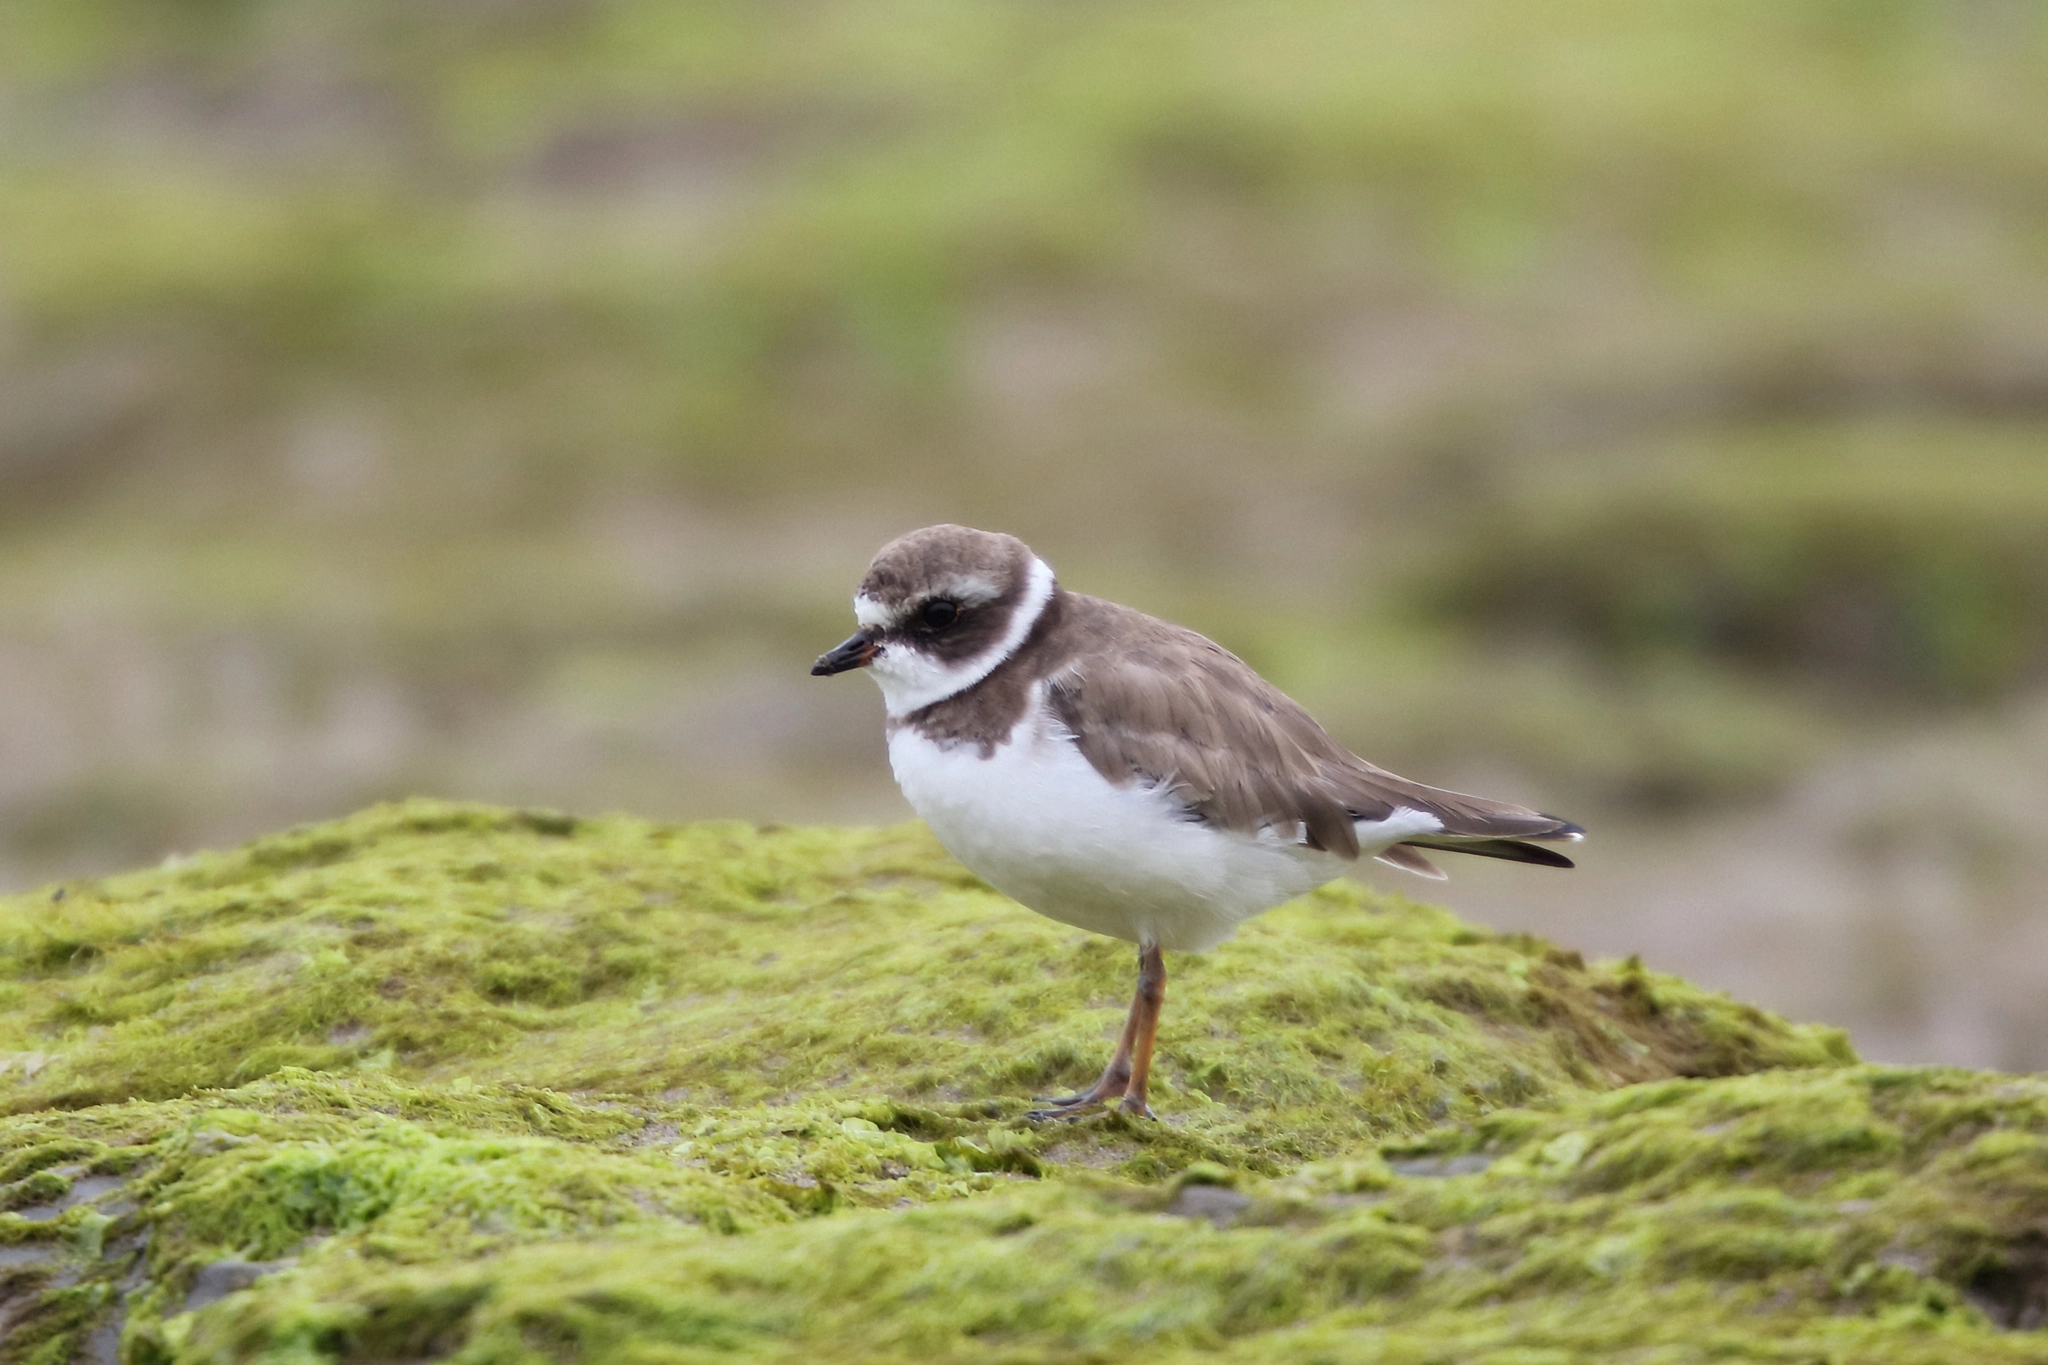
0 802 2048 1365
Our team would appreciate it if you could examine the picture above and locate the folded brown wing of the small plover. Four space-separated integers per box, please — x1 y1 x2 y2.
1051 593 1579 866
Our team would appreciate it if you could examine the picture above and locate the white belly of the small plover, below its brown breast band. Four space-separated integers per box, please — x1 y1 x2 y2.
889 706 1348 952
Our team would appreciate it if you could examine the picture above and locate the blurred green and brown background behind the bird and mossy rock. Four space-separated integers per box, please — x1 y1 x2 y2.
0 0 2048 1068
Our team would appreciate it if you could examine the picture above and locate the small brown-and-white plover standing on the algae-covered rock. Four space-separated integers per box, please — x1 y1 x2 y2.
811 524 1585 1119
